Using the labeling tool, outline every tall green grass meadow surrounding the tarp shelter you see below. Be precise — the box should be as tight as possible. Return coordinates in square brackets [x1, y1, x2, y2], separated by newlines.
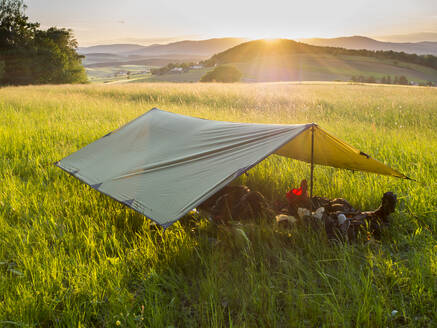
[0, 83, 437, 327]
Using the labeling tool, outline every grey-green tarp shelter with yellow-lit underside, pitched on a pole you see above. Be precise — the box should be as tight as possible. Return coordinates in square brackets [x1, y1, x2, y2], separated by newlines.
[56, 108, 406, 228]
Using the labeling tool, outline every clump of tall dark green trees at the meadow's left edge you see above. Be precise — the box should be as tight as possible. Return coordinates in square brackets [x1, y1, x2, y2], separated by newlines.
[0, 0, 87, 85]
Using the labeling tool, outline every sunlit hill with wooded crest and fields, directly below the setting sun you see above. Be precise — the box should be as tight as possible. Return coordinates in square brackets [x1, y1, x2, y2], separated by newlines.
[205, 39, 437, 82]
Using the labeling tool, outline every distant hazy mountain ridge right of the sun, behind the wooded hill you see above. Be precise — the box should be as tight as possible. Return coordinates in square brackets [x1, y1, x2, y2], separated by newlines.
[299, 36, 437, 55]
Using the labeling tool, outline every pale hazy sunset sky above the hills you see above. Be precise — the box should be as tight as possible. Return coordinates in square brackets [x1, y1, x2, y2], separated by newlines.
[25, 0, 437, 45]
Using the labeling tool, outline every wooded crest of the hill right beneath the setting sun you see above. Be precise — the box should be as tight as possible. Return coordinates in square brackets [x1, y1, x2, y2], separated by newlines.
[204, 39, 437, 69]
